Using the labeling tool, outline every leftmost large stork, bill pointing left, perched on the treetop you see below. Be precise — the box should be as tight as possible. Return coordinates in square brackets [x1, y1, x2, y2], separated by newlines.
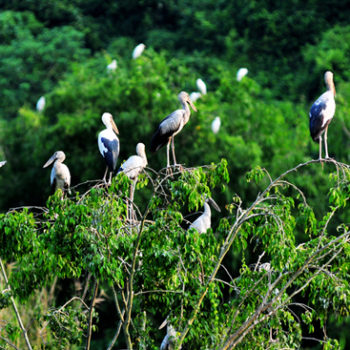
[43, 151, 71, 192]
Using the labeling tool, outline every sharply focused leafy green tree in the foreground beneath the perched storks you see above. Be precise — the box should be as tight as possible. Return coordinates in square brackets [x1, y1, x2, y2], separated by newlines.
[0, 160, 350, 349]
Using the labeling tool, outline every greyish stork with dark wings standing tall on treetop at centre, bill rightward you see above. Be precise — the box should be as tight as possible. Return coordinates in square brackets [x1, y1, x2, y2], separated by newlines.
[151, 91, 197, 168]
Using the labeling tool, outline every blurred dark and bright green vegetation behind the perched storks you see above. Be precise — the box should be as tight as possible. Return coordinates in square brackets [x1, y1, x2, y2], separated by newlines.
[0, 0, 350, 348]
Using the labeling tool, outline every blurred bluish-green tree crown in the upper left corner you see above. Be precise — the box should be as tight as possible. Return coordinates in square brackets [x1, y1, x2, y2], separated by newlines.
[0, 11, 88, 119]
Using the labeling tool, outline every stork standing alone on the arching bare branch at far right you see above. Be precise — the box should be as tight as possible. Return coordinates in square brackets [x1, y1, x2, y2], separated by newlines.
[309, 71, 335, 159]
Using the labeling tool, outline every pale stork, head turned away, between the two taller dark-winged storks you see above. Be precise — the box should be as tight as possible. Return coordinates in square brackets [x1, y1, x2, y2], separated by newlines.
[118, 142, 148, 219]
